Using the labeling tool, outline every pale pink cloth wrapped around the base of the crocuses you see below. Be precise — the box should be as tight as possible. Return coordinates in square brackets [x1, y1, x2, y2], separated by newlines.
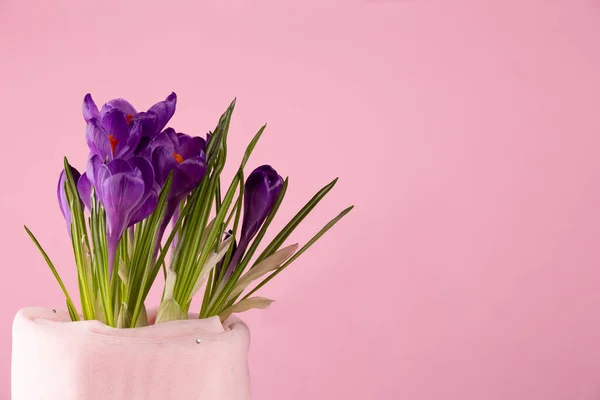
[12, 308, 250, 400]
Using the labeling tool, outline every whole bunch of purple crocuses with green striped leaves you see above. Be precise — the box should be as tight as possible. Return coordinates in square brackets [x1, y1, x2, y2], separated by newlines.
[25, 93, 352, 328]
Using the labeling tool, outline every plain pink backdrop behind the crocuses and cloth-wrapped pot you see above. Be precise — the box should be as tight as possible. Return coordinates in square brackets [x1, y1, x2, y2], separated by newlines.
[0, 0, 600, 400]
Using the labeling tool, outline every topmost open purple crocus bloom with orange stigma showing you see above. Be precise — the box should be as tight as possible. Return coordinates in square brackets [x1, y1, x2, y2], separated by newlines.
[82, 93, 177, 160]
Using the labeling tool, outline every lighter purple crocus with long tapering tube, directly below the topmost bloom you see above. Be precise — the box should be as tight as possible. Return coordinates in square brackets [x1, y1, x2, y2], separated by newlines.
[77, 155, 157, 271]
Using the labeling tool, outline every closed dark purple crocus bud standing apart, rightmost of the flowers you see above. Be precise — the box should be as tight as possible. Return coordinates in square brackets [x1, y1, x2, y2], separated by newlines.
[223, 165, 283, 282]
